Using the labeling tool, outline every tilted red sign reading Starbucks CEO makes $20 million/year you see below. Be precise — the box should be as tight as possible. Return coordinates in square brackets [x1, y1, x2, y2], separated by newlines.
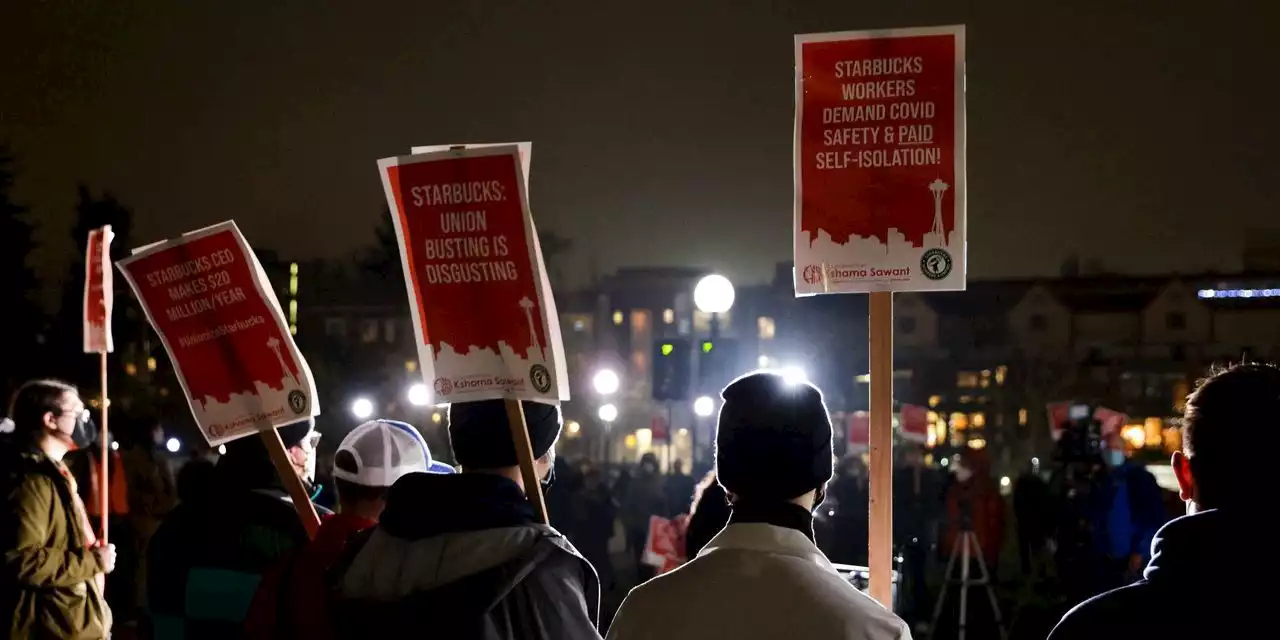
[116, 221, 319, 447]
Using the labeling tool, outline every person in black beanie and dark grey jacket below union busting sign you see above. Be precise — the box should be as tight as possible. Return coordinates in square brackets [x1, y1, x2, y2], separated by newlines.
[330, 399, 600, 640]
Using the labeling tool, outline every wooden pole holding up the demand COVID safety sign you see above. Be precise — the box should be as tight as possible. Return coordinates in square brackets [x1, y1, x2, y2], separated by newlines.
[867, 292, 893, 611]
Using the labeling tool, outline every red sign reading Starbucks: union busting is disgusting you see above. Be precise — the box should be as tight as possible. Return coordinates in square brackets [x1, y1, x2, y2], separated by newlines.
[378, 145, 568, 402]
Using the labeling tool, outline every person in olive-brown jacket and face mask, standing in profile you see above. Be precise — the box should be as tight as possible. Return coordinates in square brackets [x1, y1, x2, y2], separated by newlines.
[0, 380, 115, 639]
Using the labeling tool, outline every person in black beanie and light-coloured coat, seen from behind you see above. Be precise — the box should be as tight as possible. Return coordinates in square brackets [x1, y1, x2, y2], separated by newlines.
[608, 371, 911, 640]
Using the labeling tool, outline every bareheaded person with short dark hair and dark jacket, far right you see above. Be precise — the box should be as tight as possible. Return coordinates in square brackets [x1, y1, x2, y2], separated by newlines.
[1050, 364, 1280, 640]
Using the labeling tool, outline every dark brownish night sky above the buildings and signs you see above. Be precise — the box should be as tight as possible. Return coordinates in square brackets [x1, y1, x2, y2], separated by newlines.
[0, 0, 1280, 290]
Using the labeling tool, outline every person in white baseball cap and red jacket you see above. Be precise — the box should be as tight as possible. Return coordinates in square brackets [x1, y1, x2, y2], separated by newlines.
[246, 420, 454, 639]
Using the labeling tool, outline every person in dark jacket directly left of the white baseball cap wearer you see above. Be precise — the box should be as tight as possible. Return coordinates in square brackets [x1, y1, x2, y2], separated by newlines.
[147, 419, 328, 640]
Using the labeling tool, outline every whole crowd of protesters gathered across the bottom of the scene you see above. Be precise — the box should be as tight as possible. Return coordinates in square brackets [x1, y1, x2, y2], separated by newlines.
[0, 364, 1259, 640]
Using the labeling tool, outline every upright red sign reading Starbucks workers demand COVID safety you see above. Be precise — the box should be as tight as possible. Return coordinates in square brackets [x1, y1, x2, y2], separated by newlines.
[794, 27, 965, 296]
